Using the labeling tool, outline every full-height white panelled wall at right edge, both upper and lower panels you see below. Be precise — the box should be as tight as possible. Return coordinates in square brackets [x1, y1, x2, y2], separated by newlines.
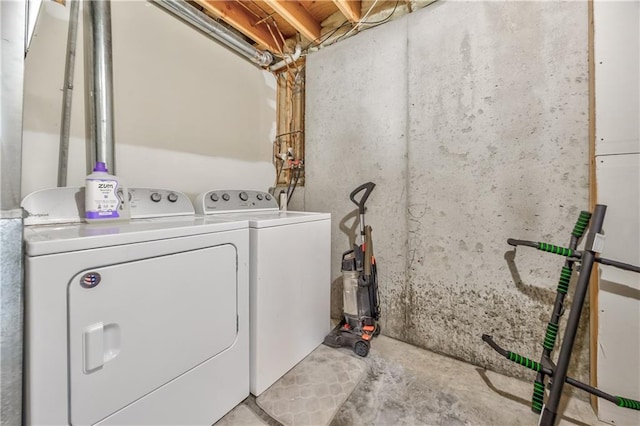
[593, 0, 640, 425]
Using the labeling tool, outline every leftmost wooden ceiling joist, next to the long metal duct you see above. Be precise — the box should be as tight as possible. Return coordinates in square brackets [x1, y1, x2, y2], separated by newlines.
[195, 0, 282, 52]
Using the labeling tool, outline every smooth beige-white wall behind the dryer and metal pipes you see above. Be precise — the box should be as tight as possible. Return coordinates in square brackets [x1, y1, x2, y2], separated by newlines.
[22, 1, 276, 196]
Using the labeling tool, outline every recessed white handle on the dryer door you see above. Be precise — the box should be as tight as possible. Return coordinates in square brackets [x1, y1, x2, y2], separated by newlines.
[82, 322, 120, 374]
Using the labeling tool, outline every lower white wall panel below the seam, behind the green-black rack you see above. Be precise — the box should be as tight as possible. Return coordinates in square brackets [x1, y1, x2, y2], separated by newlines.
[596, 154, 640, 425]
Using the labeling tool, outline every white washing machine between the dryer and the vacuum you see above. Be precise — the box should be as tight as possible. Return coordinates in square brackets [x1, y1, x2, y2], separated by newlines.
[195, 190, 331, 396]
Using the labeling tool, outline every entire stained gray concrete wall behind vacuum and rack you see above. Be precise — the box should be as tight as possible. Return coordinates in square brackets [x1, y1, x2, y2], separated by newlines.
[305, 2, 589, 380]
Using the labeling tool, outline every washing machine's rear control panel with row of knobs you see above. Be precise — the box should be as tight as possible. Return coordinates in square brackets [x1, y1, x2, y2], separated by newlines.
[195, 189, 278, 214]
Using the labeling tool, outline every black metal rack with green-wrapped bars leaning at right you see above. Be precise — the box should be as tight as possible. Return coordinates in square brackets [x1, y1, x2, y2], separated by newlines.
[482, 204, 640, 426]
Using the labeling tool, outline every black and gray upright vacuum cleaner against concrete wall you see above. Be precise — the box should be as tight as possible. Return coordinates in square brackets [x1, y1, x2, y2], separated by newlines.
[324, 182, 380, 357]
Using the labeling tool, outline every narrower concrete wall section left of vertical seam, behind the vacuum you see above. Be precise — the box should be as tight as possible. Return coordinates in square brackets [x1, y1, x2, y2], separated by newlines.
[304, 15, 407, 336]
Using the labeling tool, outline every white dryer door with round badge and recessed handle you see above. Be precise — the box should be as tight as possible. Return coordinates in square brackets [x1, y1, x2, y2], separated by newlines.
[68, 244, 238, 424]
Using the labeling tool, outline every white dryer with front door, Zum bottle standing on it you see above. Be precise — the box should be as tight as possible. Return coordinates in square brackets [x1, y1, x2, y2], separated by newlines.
[22, 188, 249, 425]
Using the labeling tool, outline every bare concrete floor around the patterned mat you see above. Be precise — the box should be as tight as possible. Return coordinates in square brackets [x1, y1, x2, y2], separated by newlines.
[221, 336, 606, 426]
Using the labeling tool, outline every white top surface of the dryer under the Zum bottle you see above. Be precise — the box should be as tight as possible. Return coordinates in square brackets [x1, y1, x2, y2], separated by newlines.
[24, 216, 248, 256]
